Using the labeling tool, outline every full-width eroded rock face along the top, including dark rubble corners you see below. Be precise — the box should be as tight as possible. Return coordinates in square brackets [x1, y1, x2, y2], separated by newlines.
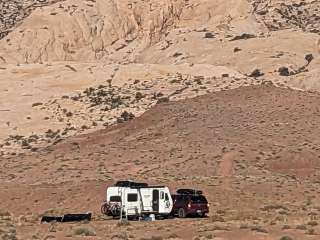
[0, 0, 320, 63]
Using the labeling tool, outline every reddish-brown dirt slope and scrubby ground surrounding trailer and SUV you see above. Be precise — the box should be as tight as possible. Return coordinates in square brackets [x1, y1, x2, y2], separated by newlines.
[0, 85, 320, 239]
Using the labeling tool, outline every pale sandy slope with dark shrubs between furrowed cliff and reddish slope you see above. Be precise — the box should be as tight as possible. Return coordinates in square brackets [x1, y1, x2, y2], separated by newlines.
[0, 63, 255, 155]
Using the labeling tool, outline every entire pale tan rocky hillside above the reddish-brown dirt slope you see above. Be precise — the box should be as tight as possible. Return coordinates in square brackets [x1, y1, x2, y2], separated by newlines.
[0, 0, 320, 158]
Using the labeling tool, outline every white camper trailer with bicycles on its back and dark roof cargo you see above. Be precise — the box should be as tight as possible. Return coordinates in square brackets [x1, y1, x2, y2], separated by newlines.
[102, 181, 173, 217]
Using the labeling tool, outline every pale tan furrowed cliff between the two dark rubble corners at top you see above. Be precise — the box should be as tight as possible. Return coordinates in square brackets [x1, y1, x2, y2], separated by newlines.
[0, 0, 260, 63]
